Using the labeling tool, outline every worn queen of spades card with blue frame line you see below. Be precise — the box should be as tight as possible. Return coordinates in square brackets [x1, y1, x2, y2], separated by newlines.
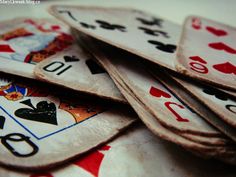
[0, 74, 136, 169]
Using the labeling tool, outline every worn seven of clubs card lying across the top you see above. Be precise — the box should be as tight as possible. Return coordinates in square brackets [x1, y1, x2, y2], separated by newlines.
[50, 5, 181, 70]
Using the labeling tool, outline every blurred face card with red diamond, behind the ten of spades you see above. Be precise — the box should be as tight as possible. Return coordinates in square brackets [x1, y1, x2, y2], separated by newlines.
[0, 18, 73, 78]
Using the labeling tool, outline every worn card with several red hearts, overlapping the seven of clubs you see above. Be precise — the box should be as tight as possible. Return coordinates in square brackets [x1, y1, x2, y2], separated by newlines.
[176, 16, 236, 91]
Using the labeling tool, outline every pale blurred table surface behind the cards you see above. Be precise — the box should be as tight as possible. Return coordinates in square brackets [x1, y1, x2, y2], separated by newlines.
[0, 0, 236, 27]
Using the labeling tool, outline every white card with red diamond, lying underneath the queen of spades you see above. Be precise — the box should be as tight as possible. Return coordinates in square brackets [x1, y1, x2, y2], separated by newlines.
[0, 126, 235, 177]
